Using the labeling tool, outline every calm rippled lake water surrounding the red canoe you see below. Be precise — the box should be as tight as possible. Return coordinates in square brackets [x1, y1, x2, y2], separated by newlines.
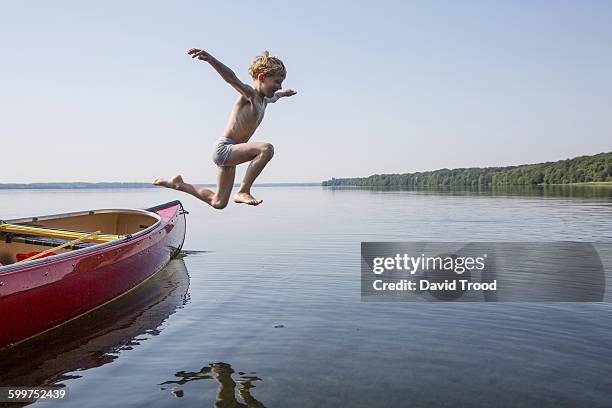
[0, 187, 612, 407]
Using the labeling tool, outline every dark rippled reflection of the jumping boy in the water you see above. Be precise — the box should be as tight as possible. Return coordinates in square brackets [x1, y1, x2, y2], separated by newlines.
[160, 363, 265, 408]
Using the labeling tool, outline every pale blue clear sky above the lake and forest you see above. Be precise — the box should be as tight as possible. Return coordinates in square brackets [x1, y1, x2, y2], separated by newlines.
[0, 0, 612, 183]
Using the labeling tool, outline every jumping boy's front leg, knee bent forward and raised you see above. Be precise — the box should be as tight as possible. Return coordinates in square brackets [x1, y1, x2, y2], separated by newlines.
[225, 142, 274, 205]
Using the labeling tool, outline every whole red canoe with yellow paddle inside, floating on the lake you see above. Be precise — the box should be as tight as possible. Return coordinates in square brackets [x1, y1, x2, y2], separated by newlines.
[0, 201, 186, 348]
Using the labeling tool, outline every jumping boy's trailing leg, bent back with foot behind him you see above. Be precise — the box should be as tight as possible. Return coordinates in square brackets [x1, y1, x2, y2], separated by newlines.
[153, 166, 236, 209]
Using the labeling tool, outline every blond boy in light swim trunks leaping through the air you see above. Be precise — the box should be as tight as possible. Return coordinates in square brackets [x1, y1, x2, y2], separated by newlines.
[153, 48, 296, 209]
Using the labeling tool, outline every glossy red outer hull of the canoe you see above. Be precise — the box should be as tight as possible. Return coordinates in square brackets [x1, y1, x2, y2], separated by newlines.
[0, 201, 185, 348]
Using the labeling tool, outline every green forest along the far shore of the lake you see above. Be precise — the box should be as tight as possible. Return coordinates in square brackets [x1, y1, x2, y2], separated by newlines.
[323, 152, 612, 187]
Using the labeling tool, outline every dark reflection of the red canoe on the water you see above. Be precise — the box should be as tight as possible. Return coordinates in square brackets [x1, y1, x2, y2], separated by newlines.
[0, 259, 189, 387]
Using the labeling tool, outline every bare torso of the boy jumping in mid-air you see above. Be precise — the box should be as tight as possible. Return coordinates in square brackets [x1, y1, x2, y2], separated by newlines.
[223, 95, 267, 143]
